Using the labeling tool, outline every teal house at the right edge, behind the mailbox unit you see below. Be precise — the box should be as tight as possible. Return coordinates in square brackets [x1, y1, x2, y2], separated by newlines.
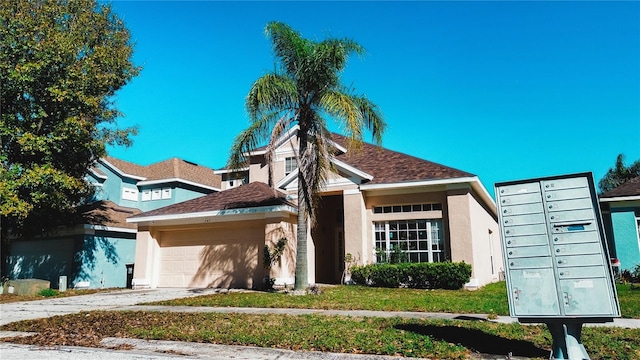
[600, 176, 640, 270]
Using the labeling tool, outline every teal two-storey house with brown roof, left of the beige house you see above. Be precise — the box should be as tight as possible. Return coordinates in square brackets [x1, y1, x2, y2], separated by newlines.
[4, 157, 220, 288]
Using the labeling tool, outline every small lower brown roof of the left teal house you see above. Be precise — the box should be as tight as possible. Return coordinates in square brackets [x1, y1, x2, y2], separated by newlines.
[78, 200, 142, 229]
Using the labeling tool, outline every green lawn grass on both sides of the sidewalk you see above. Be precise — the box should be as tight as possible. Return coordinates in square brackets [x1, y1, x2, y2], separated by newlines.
[0, 282, 640, 360]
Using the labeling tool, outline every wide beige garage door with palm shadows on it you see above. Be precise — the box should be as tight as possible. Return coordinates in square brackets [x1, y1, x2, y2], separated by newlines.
[158, 224, 264, 288]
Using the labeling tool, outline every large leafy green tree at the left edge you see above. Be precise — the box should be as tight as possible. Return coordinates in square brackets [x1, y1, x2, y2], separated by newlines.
[0, 0, 140, 239]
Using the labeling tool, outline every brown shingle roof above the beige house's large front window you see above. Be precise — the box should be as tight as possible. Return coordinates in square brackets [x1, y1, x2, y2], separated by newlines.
[332, 133, 475, 184]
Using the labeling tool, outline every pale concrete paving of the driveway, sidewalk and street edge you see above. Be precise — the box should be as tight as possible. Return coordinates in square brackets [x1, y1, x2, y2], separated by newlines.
[0, 289, 640, 360]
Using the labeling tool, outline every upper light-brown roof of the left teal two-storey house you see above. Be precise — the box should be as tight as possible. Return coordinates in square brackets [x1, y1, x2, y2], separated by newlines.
[99, 156, 221, 189]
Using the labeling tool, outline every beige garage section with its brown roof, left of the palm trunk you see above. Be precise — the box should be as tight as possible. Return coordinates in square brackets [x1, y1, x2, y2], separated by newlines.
[127, 182, 297, 289]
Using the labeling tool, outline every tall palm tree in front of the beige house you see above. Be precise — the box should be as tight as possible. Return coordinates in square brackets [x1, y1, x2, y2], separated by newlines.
[229, 22, 385, 290]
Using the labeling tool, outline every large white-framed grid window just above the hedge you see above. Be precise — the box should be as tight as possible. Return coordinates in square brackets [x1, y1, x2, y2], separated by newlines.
[374, 220, 444, 262]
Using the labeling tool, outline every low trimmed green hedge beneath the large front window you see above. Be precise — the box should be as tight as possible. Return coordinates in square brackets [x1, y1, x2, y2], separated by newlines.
[351, 262, 471, 290]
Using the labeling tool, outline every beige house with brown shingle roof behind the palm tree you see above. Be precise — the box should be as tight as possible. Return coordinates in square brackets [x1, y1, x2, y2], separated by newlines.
[127, 128, 503, 287]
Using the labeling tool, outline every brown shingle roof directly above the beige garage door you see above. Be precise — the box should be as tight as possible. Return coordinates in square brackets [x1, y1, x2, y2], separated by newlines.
[132, 182, 295, 218]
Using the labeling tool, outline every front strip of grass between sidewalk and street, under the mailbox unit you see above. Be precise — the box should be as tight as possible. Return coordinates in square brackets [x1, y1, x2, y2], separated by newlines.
[1, 311, 640, 360]
